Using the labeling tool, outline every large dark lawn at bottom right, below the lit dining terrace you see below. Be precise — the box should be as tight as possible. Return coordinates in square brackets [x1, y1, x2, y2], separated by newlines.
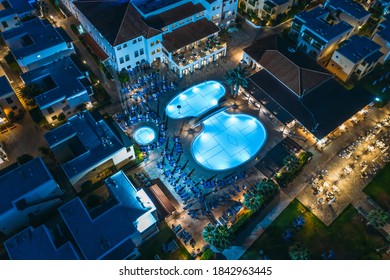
[242, 199, 385, 260]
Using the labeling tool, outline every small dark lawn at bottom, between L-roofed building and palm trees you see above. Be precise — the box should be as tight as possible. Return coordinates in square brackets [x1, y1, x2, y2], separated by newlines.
[140, 222, 193, 260]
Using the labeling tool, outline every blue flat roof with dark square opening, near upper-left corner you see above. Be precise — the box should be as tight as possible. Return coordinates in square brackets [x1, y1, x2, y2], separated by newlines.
[2, 18, 65, 59]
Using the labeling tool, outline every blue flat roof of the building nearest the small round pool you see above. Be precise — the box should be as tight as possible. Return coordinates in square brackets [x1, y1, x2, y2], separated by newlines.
[45, 111, 124, 178]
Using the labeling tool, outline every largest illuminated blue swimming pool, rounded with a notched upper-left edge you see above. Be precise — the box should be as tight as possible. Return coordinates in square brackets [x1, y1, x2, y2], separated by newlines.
[191, 112, 267, 171]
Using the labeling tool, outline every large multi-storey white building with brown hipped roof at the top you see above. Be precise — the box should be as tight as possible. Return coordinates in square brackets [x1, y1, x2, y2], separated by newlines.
[58, 0, 237, 77]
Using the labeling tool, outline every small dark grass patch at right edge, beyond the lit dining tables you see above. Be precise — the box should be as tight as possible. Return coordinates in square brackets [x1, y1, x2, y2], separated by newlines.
[364, 164, 390, 210]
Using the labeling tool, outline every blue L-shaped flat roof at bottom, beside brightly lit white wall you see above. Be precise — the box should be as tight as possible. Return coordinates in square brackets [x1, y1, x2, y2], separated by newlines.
[58, 197, 136, 260]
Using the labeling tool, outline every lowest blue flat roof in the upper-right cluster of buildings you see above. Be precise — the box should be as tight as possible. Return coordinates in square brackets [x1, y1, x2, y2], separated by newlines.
[337, 35, 383, 63]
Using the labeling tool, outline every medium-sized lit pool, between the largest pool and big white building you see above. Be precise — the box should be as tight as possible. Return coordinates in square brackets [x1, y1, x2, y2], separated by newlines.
[165, 81, 225, 119]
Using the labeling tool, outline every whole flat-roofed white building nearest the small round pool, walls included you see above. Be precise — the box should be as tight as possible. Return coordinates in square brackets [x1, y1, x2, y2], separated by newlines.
[45, 111, 135, 191]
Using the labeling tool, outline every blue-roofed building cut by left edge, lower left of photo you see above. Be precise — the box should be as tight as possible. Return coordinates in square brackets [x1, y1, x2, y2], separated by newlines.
[0, 158, 63, 236]
